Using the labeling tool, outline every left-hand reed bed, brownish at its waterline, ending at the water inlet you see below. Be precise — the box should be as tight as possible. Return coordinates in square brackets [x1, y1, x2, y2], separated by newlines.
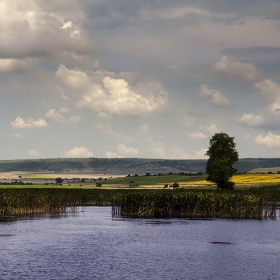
[0, 188, 132, 217]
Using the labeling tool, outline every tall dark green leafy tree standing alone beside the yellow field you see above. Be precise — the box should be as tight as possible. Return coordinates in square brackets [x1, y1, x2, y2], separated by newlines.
[205, 132, 239, 190]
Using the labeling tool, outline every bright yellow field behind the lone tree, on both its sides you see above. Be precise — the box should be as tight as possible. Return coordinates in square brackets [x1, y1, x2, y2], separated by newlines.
[179, 174, 280, 185]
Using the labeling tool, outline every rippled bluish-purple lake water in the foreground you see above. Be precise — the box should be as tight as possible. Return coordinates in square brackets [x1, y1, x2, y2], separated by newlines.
[0, 207, 280, 280]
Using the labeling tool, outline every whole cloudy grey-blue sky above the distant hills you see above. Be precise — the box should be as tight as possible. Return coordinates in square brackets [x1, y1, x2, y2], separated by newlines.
[0, 0, 280, 160]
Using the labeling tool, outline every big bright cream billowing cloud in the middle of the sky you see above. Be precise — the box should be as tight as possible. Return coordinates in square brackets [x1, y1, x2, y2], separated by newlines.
[56, 65, 168, 116]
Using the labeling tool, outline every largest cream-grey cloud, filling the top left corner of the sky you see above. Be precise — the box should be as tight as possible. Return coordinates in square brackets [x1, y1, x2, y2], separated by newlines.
[0, 0, 94, 59]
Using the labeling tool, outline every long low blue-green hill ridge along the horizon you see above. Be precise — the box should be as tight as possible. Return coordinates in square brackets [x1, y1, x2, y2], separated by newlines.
[0, 158, 280, 174]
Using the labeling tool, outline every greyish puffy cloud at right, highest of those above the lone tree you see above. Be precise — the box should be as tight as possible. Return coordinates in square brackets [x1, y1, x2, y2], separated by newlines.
[214, 56, 261, 82]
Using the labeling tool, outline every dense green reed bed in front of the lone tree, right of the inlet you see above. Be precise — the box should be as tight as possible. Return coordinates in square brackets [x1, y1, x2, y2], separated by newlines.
[112, 187, 280, 219]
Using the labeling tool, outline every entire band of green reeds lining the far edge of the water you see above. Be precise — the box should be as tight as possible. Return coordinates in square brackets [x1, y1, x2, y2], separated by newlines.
[0, 186, 280, 219]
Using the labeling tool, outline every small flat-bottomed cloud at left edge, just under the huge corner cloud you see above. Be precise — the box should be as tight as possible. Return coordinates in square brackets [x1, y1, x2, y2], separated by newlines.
[0, 58, 33, 73]
